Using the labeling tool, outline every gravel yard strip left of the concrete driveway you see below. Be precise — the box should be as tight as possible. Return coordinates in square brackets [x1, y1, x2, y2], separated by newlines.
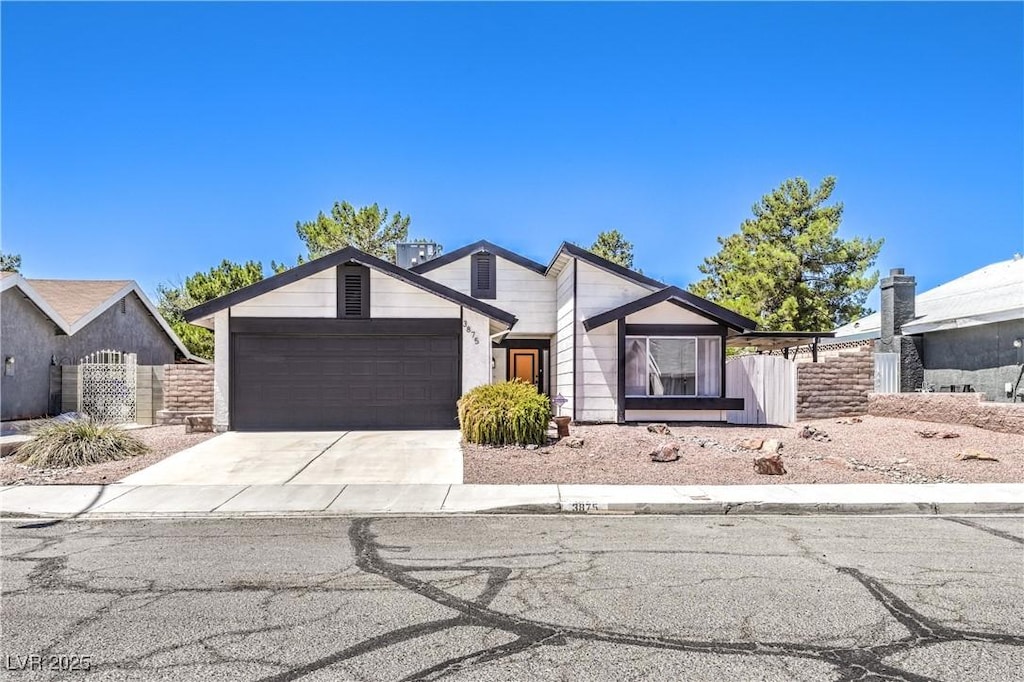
[0, 426, 216, 485]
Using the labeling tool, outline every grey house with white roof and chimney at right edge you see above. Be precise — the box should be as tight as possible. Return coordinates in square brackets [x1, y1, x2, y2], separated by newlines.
[835, 256, 1024, 401]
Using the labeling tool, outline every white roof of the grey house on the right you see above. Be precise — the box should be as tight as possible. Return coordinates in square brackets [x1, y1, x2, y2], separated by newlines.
[836, 258, 1024, 341]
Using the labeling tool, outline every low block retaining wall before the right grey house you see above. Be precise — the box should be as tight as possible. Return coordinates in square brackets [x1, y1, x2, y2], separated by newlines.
[867, 393, 1024, 433]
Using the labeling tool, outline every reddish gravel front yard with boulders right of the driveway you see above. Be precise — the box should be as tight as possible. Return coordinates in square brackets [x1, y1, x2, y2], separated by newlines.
[463, 417, 1024, 485]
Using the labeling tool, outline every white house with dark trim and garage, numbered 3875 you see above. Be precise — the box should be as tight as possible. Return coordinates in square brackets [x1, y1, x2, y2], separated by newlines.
[185, 242, 756, 430]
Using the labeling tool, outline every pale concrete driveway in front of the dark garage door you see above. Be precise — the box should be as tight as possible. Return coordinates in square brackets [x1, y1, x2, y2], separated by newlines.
[121, 431, 462, 485]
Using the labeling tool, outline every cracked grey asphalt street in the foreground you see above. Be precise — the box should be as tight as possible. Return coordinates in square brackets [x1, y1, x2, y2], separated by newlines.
[0, 515, 1024, 682]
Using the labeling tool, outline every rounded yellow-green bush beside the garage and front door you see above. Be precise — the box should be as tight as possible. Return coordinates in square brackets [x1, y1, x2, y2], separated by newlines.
[459, 379, 551, 445]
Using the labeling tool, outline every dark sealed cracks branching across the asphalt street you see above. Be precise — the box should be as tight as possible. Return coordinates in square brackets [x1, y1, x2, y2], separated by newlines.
[0, 518, 1024, 682]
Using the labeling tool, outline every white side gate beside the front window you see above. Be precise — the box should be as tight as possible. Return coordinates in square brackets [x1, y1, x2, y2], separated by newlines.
[725, 355, 797, 424]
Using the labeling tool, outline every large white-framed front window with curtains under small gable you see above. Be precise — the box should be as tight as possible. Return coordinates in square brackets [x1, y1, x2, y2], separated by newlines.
[626, 336, 722, 397]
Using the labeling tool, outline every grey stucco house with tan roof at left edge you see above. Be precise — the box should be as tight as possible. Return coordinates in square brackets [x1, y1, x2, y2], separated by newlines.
[0, 272, 194, 420]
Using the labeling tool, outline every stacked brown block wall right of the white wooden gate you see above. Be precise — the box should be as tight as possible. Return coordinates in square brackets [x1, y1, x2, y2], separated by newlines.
[797, 348, 874, 420]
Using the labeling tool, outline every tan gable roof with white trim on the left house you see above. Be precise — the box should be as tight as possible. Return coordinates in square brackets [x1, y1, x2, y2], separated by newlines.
[0, 272, 199, 363]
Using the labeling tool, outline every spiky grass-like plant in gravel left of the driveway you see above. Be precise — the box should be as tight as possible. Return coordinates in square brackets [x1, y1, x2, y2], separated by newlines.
[16, 419, 150, 469]
